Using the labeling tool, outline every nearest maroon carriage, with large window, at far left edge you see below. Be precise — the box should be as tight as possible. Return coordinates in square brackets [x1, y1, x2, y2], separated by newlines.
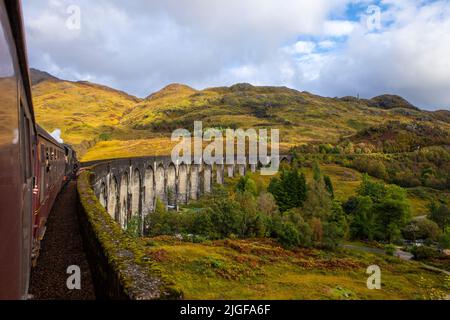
[0, 0, 36, 299]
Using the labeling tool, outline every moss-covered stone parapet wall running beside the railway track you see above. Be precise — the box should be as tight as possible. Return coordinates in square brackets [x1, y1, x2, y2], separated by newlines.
[77, 171, 183, 300]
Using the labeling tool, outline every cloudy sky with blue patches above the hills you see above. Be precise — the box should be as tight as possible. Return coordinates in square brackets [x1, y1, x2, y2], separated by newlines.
[23, 0, 450, 110]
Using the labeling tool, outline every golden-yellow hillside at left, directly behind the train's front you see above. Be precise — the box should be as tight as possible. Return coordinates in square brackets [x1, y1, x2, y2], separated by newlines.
[33, 73, 139, 145]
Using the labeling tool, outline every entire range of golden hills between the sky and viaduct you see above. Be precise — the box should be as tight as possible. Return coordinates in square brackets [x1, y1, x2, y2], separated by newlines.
[29, 72, 450, 160]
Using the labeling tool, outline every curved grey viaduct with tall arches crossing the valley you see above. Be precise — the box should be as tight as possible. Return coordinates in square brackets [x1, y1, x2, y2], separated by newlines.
[83, 155, 292, 228]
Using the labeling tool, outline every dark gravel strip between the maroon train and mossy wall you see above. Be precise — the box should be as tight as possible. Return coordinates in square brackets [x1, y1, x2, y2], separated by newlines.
[30, 182, 95, 300]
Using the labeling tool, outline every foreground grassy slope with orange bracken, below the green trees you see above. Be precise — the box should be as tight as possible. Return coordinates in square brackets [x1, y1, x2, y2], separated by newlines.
[144, 237, 450, 300]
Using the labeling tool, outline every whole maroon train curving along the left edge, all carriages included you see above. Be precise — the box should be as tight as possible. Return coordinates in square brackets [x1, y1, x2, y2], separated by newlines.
[0, 0, 77, 300]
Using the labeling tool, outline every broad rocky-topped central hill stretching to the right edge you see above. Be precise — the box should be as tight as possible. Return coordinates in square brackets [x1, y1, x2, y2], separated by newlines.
[121, 80, 448, 144]
